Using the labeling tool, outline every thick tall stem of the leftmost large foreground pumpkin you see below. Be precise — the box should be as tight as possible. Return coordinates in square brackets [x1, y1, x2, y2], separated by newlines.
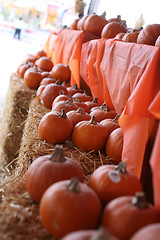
[49, 145, 66, 162]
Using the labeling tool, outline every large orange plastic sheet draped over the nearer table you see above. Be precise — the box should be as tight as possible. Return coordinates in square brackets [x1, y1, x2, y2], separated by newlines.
[80, 39, 160, 208]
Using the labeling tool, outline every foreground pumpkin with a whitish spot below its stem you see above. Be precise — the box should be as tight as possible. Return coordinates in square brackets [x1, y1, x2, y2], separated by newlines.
[88, 162, 143, 206]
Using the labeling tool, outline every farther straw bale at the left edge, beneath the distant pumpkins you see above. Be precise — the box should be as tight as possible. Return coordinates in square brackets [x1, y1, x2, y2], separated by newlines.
[0, 73, 36, 165]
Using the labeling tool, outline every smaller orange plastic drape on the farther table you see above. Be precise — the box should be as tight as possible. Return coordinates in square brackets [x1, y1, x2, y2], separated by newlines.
[51, 29, 99, 87]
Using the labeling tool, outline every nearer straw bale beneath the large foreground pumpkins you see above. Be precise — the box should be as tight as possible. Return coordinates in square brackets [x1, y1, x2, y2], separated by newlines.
[0, 98, 109, 240]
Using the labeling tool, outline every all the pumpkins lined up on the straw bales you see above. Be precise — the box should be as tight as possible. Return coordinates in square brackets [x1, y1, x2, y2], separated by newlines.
[17, 50, 160, 240]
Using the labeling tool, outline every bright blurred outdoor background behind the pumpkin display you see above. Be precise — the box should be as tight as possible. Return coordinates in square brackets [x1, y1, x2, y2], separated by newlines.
[0, 0, 160, 118]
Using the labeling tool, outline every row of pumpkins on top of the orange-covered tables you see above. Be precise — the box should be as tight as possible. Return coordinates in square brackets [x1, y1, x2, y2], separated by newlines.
[70, 14, 160, 47]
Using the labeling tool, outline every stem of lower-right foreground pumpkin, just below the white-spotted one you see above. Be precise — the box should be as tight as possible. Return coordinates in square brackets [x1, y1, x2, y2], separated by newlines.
[131, 192, 148, 209]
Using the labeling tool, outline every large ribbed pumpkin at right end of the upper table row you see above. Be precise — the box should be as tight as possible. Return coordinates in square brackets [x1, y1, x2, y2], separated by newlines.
[137, 24, 160, 46]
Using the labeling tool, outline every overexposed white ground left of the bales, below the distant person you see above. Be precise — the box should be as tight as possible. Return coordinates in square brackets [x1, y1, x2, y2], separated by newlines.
[0, 26, 49, 117]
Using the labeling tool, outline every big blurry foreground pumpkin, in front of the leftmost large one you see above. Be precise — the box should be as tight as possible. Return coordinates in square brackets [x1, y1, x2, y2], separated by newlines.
[40, 178, 101, 238]
